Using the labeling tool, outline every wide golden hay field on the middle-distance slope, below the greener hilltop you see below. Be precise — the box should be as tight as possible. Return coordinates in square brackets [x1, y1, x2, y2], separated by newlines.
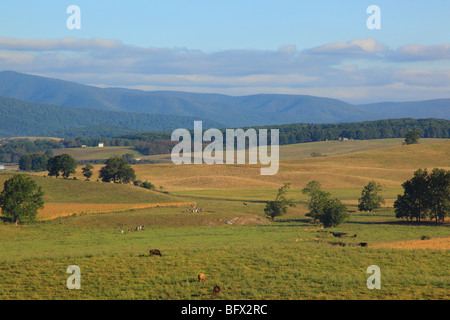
[130, 141, 450, 190]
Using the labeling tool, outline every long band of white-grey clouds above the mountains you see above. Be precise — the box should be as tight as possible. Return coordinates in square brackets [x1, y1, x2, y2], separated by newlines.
[0, 38, 450, 102]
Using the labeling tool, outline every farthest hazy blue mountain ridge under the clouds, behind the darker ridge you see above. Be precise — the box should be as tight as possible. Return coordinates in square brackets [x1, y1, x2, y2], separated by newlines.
[0, 71, 450, 127]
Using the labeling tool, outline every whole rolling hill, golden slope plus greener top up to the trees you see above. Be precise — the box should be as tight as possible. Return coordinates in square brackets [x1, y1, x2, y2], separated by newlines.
[129, 139, 450, 200]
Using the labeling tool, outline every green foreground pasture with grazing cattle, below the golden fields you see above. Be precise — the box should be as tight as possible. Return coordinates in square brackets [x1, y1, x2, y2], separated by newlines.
[0, 200, 450, 300]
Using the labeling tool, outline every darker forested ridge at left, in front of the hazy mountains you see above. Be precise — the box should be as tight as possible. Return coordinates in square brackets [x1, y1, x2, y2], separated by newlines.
[0, 97, 223, 137]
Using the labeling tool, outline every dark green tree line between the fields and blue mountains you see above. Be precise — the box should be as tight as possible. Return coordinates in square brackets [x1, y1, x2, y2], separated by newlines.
[0, 119, 450, 163]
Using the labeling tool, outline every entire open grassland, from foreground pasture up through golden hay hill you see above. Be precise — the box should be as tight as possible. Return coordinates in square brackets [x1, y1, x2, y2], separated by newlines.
[0, 141, 450, 300]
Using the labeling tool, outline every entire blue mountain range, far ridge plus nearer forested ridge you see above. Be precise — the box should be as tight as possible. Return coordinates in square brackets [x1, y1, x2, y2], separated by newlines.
[0, 71, 450, 136]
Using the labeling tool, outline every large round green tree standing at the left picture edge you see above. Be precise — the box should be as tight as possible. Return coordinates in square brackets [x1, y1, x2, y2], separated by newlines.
[0, 174, 44, 224]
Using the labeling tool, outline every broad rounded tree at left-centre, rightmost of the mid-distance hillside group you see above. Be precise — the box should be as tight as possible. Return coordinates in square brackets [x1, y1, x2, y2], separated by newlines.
[99, 156, 136, 183]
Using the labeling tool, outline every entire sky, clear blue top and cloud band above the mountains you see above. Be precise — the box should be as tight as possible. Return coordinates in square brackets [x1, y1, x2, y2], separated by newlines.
[0, 0, 450, 103]
